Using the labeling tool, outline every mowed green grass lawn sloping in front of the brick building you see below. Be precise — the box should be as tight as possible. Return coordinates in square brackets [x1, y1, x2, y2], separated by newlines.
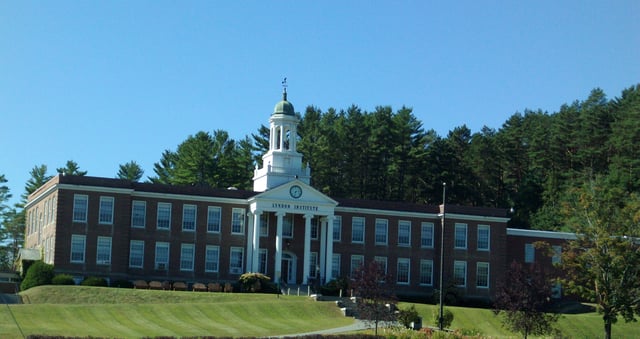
[0, 286, 640, 338]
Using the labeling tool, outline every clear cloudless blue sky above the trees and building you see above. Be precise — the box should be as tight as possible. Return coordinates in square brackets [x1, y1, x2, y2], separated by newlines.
[0, 0, 640, 206]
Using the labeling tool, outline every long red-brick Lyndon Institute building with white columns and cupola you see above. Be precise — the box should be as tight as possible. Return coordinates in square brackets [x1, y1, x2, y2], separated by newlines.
[25, 91, 568, 299]
